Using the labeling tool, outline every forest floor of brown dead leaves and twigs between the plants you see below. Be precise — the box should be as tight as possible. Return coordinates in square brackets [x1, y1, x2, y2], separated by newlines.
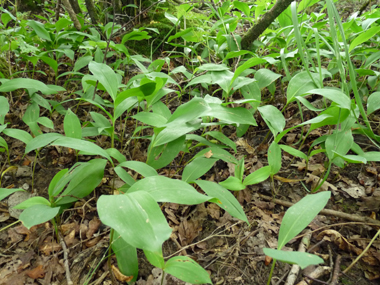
[0, 0, 380, 285]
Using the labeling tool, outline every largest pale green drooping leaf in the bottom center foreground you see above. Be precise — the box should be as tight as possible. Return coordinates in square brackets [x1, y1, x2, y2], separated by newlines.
[97, 191, 172, 252]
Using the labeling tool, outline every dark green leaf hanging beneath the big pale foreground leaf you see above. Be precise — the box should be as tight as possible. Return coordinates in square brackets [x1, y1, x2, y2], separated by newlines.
[111, 230, 139, 282]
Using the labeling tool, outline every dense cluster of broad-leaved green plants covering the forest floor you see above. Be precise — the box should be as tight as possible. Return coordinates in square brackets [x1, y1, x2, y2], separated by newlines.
[0, 0, 380, 284]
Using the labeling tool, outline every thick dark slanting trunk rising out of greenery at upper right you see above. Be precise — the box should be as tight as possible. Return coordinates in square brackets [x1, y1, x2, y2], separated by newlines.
[241, 0, 293, 49]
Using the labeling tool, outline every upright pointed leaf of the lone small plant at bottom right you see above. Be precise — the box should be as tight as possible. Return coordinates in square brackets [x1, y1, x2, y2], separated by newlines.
[278, 191, 331, 250]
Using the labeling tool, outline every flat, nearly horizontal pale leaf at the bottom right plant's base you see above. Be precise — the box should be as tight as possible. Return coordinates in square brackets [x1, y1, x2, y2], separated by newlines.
[263, 248, 324, 269]
